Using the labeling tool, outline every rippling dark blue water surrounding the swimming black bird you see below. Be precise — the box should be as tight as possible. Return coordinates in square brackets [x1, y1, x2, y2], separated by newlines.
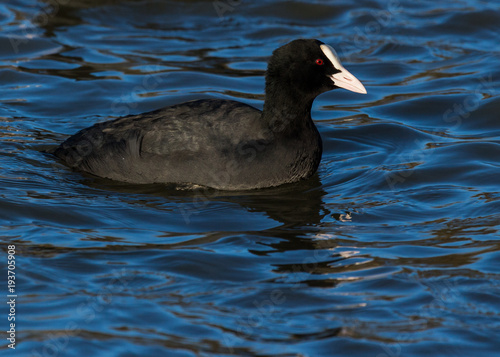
[0, 0, 500, 357]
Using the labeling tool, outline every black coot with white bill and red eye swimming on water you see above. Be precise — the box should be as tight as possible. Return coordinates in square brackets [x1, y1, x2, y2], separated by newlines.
[53, 39, 366, 190]
